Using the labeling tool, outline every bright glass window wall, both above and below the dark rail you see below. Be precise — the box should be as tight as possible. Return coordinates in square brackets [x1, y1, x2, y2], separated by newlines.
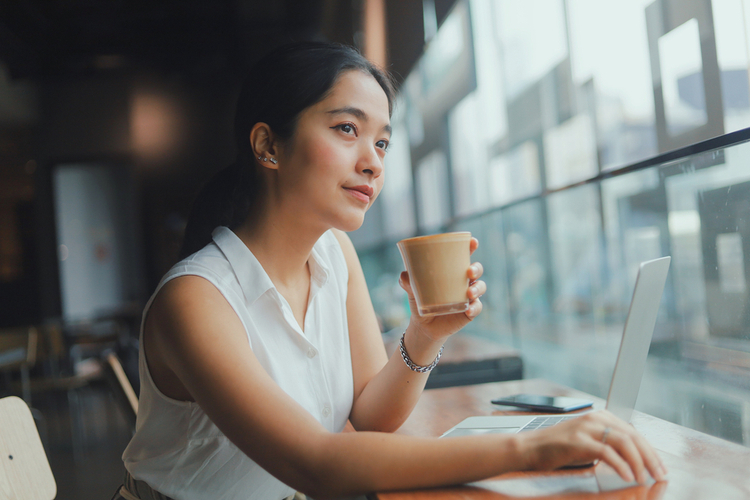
[360, 0, 750, 446]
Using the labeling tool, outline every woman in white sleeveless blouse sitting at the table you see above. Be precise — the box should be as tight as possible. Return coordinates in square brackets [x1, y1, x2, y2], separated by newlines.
[116, 43, 663, 500]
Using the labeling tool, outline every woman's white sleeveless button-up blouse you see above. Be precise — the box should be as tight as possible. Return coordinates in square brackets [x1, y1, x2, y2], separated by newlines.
[123, 227, 354, 500]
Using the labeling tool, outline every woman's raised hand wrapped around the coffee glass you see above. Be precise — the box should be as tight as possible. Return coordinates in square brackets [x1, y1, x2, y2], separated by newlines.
[399, 238, 487, 341]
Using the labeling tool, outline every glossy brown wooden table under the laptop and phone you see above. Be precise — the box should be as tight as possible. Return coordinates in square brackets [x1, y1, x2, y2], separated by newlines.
[368, 379, 750, 500]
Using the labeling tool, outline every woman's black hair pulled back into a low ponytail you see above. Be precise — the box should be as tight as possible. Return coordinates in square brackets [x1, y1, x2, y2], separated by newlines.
[180, 42, 395, 259]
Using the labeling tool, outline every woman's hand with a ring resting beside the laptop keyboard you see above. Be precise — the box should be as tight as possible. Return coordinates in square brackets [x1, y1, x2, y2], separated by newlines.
[517, 410, 667, 484]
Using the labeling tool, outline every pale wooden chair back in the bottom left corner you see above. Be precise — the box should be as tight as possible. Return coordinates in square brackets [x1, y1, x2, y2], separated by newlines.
[0, 396, 57, 500]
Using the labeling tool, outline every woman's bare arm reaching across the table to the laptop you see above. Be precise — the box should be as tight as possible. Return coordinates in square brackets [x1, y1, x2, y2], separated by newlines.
[144, 276, 658, 498]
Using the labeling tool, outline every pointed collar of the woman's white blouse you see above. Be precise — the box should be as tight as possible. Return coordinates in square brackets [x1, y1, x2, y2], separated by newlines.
[212, 226, 330, 305]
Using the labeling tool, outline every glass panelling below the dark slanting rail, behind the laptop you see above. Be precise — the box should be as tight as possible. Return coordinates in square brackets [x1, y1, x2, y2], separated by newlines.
[360, 129, 750, 446]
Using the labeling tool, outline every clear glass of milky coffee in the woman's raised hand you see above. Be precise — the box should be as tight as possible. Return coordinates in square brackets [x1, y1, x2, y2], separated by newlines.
[398, 231, 471, 316]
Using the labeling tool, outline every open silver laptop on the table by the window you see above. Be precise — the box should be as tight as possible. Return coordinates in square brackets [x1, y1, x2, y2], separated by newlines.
[441, 257, 671, 437]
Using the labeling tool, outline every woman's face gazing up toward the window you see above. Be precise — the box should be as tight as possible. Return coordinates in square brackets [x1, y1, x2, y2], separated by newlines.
[277, 70, 391, 231]
